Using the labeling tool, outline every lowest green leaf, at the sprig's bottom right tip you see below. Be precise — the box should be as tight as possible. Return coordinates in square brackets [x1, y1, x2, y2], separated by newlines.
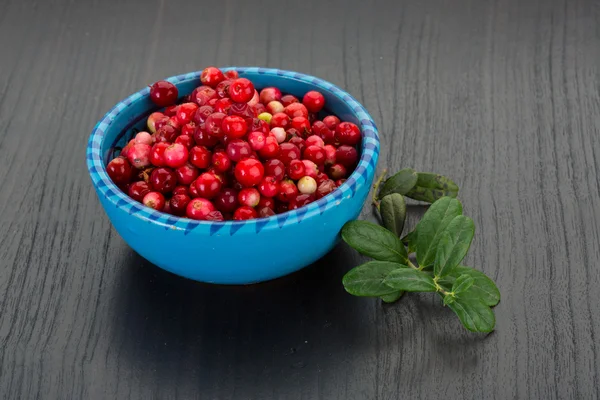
[447, 291, 496, 332]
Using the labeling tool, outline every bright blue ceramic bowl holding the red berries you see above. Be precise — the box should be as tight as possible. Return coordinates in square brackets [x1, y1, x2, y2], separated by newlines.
[87, 67, 379, 284]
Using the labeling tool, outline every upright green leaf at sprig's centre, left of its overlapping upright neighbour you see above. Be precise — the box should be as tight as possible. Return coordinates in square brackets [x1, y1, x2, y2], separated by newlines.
[416, 197, 462, 267]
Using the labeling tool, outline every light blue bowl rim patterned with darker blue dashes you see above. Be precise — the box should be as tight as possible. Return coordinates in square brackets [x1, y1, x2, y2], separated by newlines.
[86, 66, 380, 236]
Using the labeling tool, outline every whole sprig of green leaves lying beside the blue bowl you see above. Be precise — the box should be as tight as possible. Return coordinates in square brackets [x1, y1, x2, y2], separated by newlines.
[342, 168, 500, 332]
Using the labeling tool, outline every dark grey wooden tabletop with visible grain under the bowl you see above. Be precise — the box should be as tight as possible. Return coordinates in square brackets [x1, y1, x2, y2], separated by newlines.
[0, 0, 600, 400]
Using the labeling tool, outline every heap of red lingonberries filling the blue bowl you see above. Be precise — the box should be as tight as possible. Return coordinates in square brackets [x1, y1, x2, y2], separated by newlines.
[106, 67, 361, 221]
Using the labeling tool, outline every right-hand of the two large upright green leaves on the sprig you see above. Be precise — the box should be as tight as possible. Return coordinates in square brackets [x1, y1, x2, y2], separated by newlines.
[433, 215, 475, 277]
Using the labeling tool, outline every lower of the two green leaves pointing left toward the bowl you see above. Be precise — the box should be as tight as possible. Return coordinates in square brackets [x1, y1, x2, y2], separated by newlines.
[342, 261, 408, 297]
